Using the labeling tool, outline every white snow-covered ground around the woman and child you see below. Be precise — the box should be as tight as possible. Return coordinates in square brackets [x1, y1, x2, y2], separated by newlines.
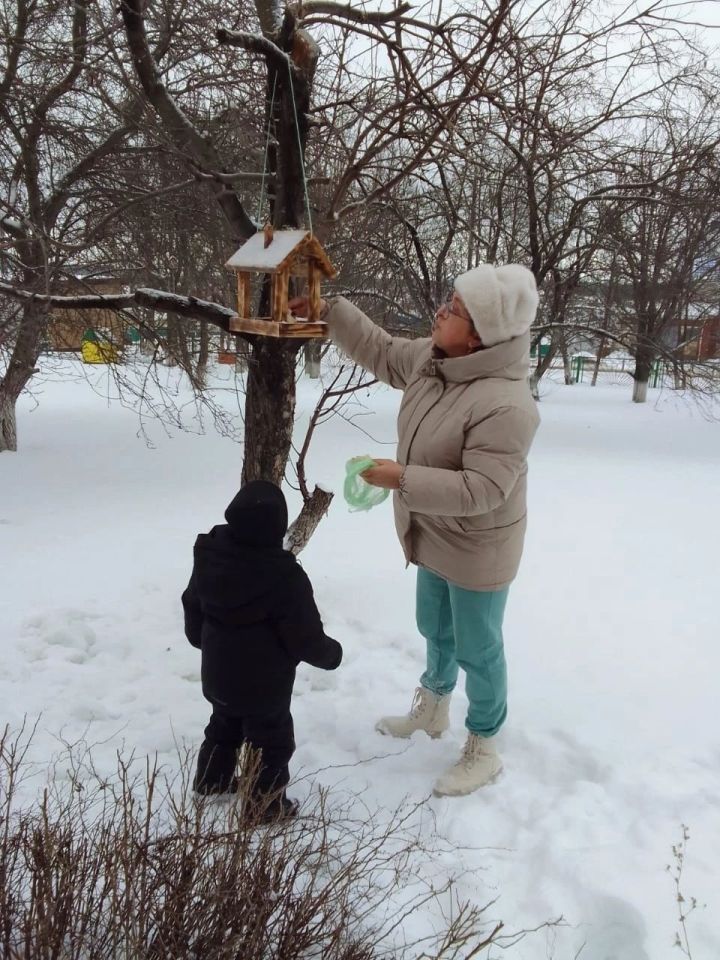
[0, 361, 720, 960]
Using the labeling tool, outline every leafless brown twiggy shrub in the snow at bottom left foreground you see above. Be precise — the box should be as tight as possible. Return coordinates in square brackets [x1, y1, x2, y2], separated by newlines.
[0, 728, 502, 960]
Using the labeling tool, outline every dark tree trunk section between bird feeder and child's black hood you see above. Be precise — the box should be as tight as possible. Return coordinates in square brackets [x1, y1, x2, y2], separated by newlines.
[242, 337, 299, 486]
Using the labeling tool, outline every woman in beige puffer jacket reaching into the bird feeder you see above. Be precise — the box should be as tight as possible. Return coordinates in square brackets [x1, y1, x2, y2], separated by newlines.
[290, 264, 539, 796]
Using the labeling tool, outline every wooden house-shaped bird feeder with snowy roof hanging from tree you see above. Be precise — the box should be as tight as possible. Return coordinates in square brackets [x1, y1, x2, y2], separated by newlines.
[225, 226, 337, 339]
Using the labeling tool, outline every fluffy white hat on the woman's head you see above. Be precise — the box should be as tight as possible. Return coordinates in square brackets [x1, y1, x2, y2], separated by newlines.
[455, 263, 538, 347]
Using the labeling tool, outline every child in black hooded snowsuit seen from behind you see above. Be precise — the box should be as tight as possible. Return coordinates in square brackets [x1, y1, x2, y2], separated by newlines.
[182, 480, 342, 819]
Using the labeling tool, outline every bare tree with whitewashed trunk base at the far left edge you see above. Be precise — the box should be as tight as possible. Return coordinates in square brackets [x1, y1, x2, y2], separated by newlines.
[0, 0, 180, 451]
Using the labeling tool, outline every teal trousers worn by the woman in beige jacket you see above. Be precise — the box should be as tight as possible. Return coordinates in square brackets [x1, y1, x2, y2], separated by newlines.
[416, 567, 509, 737]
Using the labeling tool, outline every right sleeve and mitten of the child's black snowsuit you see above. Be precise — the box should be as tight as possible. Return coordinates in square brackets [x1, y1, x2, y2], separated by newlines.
[277, 567, 342, 670]
